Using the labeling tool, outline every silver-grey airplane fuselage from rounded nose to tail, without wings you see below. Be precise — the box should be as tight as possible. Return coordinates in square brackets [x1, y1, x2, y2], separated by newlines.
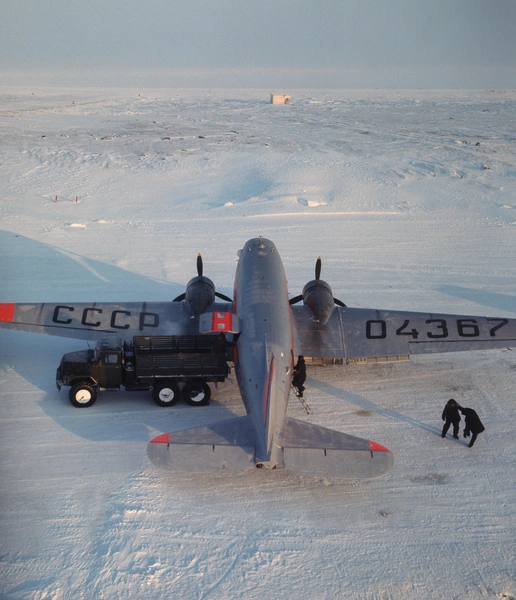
[234, 238, 293, 468]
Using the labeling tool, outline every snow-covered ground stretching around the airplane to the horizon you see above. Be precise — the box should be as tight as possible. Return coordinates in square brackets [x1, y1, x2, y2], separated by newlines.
[0, 88, 516, 600]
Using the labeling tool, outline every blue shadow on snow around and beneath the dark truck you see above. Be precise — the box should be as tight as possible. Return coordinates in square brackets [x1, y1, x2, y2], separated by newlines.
[0, 330, 236, 442]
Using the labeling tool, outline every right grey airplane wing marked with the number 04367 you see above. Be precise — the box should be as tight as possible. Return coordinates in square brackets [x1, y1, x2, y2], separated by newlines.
[292, 306, 516, 364]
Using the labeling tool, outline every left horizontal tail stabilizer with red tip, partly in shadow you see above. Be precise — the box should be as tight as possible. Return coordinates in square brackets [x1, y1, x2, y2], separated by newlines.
[147, 417, 256, 473]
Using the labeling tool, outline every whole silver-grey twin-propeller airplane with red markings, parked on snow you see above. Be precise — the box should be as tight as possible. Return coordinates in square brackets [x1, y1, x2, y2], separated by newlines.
[0, 237, 516, 479]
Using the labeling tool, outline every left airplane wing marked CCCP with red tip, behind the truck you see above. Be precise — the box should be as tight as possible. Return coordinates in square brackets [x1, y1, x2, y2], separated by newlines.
[0, 302, 231, 340]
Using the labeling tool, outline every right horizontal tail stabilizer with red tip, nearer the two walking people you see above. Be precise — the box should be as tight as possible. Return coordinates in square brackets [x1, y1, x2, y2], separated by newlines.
[282, 419, 394, 479]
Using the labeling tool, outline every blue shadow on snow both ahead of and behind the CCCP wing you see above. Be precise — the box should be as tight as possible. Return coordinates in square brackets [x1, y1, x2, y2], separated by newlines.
[0, 231, 236, 441]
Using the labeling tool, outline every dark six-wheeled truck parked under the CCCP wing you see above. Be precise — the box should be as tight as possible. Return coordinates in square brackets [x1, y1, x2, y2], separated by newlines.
[56, 335, 230, 408]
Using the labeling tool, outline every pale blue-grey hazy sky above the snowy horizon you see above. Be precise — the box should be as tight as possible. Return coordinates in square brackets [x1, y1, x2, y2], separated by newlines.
[0, 0, 516, 89]
